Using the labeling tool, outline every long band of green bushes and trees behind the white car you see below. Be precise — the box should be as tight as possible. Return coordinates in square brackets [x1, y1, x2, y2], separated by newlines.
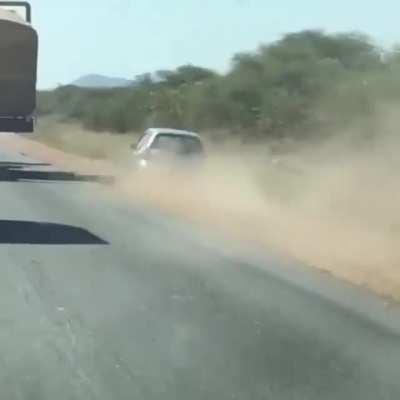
[38, 31, 400, 140]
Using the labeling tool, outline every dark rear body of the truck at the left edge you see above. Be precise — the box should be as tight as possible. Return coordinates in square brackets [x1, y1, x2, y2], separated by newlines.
[0, 2, 38, 132]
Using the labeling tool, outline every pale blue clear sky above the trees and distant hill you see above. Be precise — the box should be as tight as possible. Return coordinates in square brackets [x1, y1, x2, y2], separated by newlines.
[16, 0, 400, 89]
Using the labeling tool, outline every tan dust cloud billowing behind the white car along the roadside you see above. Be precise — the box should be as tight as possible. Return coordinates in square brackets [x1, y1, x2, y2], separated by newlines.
[118, 109, 400, 300]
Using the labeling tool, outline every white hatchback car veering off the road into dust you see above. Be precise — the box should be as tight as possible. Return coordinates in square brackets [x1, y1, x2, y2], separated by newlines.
[131, 128, 205, 168]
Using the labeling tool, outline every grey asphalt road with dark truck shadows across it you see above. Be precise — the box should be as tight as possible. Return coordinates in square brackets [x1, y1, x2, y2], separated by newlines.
[0, 148, 400, 400]
